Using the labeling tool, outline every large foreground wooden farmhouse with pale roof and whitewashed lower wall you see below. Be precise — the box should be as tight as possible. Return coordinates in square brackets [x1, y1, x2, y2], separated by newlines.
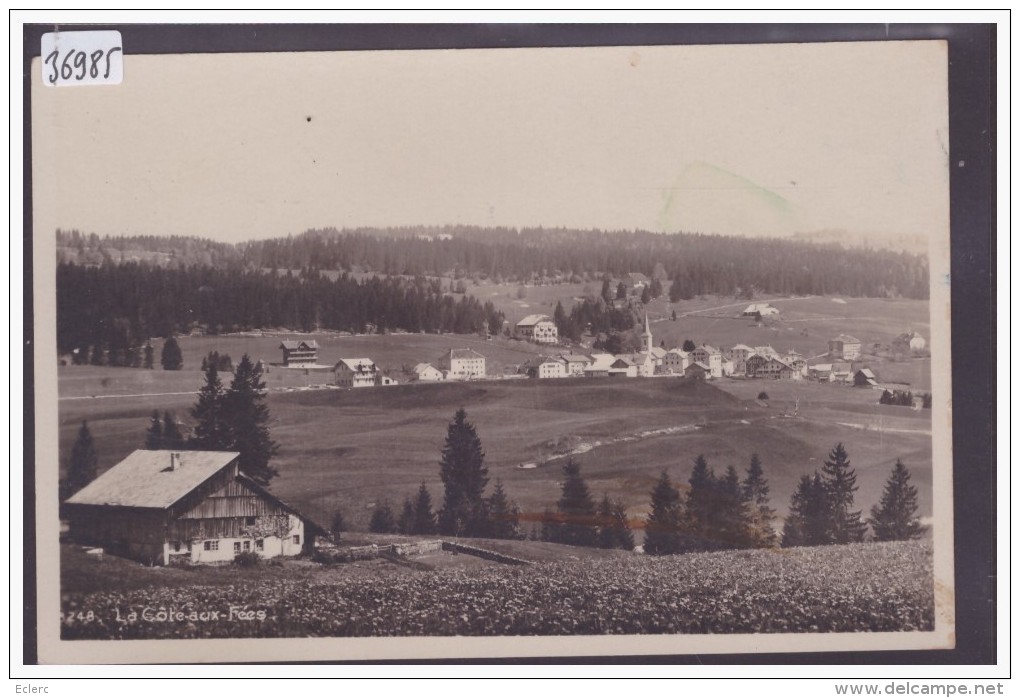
[66, 450, 326, 565]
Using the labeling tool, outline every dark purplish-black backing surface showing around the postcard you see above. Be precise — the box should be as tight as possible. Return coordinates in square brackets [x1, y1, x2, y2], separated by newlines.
[21, 20, 997, 665]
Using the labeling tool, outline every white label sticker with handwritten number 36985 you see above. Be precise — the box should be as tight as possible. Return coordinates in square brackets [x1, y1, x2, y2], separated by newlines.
[41, 32, 124, 87]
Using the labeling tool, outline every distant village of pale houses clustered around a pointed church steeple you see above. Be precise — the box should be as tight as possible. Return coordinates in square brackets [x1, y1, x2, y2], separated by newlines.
[279, 303, 926, 390]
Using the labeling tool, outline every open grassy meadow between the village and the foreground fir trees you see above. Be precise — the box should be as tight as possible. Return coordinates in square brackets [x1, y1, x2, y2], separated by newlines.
[60, 367, 931, 530]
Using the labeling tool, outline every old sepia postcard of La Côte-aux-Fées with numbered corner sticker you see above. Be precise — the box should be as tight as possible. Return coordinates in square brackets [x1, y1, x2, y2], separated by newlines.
[31, 31, 955, 663]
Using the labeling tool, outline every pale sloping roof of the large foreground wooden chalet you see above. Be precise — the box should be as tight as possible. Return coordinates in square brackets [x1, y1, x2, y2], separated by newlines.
[67, 450, 239, 509]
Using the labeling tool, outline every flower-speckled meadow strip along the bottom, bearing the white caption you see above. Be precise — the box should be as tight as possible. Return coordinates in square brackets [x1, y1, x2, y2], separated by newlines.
[61, 541, 934, 639]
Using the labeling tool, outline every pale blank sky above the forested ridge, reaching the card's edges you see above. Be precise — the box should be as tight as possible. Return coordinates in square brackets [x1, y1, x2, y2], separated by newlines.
[33, 42, 949, 242]
